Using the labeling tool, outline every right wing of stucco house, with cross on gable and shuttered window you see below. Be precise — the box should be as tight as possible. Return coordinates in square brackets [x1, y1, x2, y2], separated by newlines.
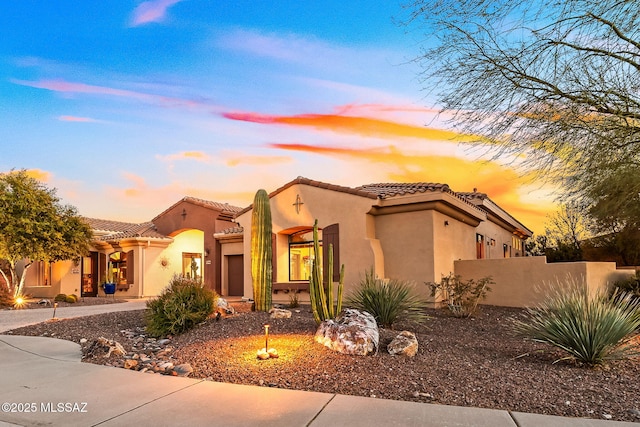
[215, 177, 532, 299]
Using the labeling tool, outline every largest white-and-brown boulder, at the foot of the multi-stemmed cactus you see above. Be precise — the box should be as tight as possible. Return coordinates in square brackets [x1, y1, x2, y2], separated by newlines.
[315, 308, 380, 356]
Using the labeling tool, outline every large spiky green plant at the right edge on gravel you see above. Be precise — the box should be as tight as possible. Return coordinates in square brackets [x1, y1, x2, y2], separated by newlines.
[514, 283, 640, 366]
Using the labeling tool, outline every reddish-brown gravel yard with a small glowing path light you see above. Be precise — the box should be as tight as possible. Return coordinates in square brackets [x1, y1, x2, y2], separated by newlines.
[2, 304, 640, 422]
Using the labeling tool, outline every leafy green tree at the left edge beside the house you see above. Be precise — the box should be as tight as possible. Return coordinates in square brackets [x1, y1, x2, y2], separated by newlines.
[0, 170, 92, 297]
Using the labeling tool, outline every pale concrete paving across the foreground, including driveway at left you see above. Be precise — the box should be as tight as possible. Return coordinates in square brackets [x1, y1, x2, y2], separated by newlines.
[0, 303, 639, 427]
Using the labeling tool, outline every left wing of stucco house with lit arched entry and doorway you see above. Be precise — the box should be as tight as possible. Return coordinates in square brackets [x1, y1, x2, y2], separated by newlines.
[25, 197, 241, 298]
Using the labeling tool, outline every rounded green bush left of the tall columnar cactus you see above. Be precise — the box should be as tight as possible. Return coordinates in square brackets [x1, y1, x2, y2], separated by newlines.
[146, 275, 218, 337]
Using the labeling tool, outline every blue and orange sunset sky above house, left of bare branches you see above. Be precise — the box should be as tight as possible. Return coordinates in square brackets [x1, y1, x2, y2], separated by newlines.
[0, 0, 554, 233]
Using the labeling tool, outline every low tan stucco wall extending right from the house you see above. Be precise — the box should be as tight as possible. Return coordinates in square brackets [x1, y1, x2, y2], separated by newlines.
[454, 256, 634, 307]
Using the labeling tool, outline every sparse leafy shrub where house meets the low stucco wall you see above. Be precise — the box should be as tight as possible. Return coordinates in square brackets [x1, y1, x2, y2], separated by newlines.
[426, 273, 495, 317]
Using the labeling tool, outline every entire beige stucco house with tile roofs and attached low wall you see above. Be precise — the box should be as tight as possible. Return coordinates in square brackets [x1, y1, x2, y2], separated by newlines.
[20, 177, 633, 307]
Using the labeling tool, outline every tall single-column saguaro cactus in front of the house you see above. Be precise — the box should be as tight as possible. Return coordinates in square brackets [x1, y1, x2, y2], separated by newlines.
[251, 189, 273, 311]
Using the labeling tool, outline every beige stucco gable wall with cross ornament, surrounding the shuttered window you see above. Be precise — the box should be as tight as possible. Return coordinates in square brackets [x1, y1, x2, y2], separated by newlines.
[237, 184, 384, 301]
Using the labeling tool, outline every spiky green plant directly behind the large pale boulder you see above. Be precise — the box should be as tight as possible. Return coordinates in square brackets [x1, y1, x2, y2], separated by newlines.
[345, 268, 427, 328]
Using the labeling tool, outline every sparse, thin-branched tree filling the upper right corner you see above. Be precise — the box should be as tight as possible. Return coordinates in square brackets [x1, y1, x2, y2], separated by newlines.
[407, 0, 640, 217]
